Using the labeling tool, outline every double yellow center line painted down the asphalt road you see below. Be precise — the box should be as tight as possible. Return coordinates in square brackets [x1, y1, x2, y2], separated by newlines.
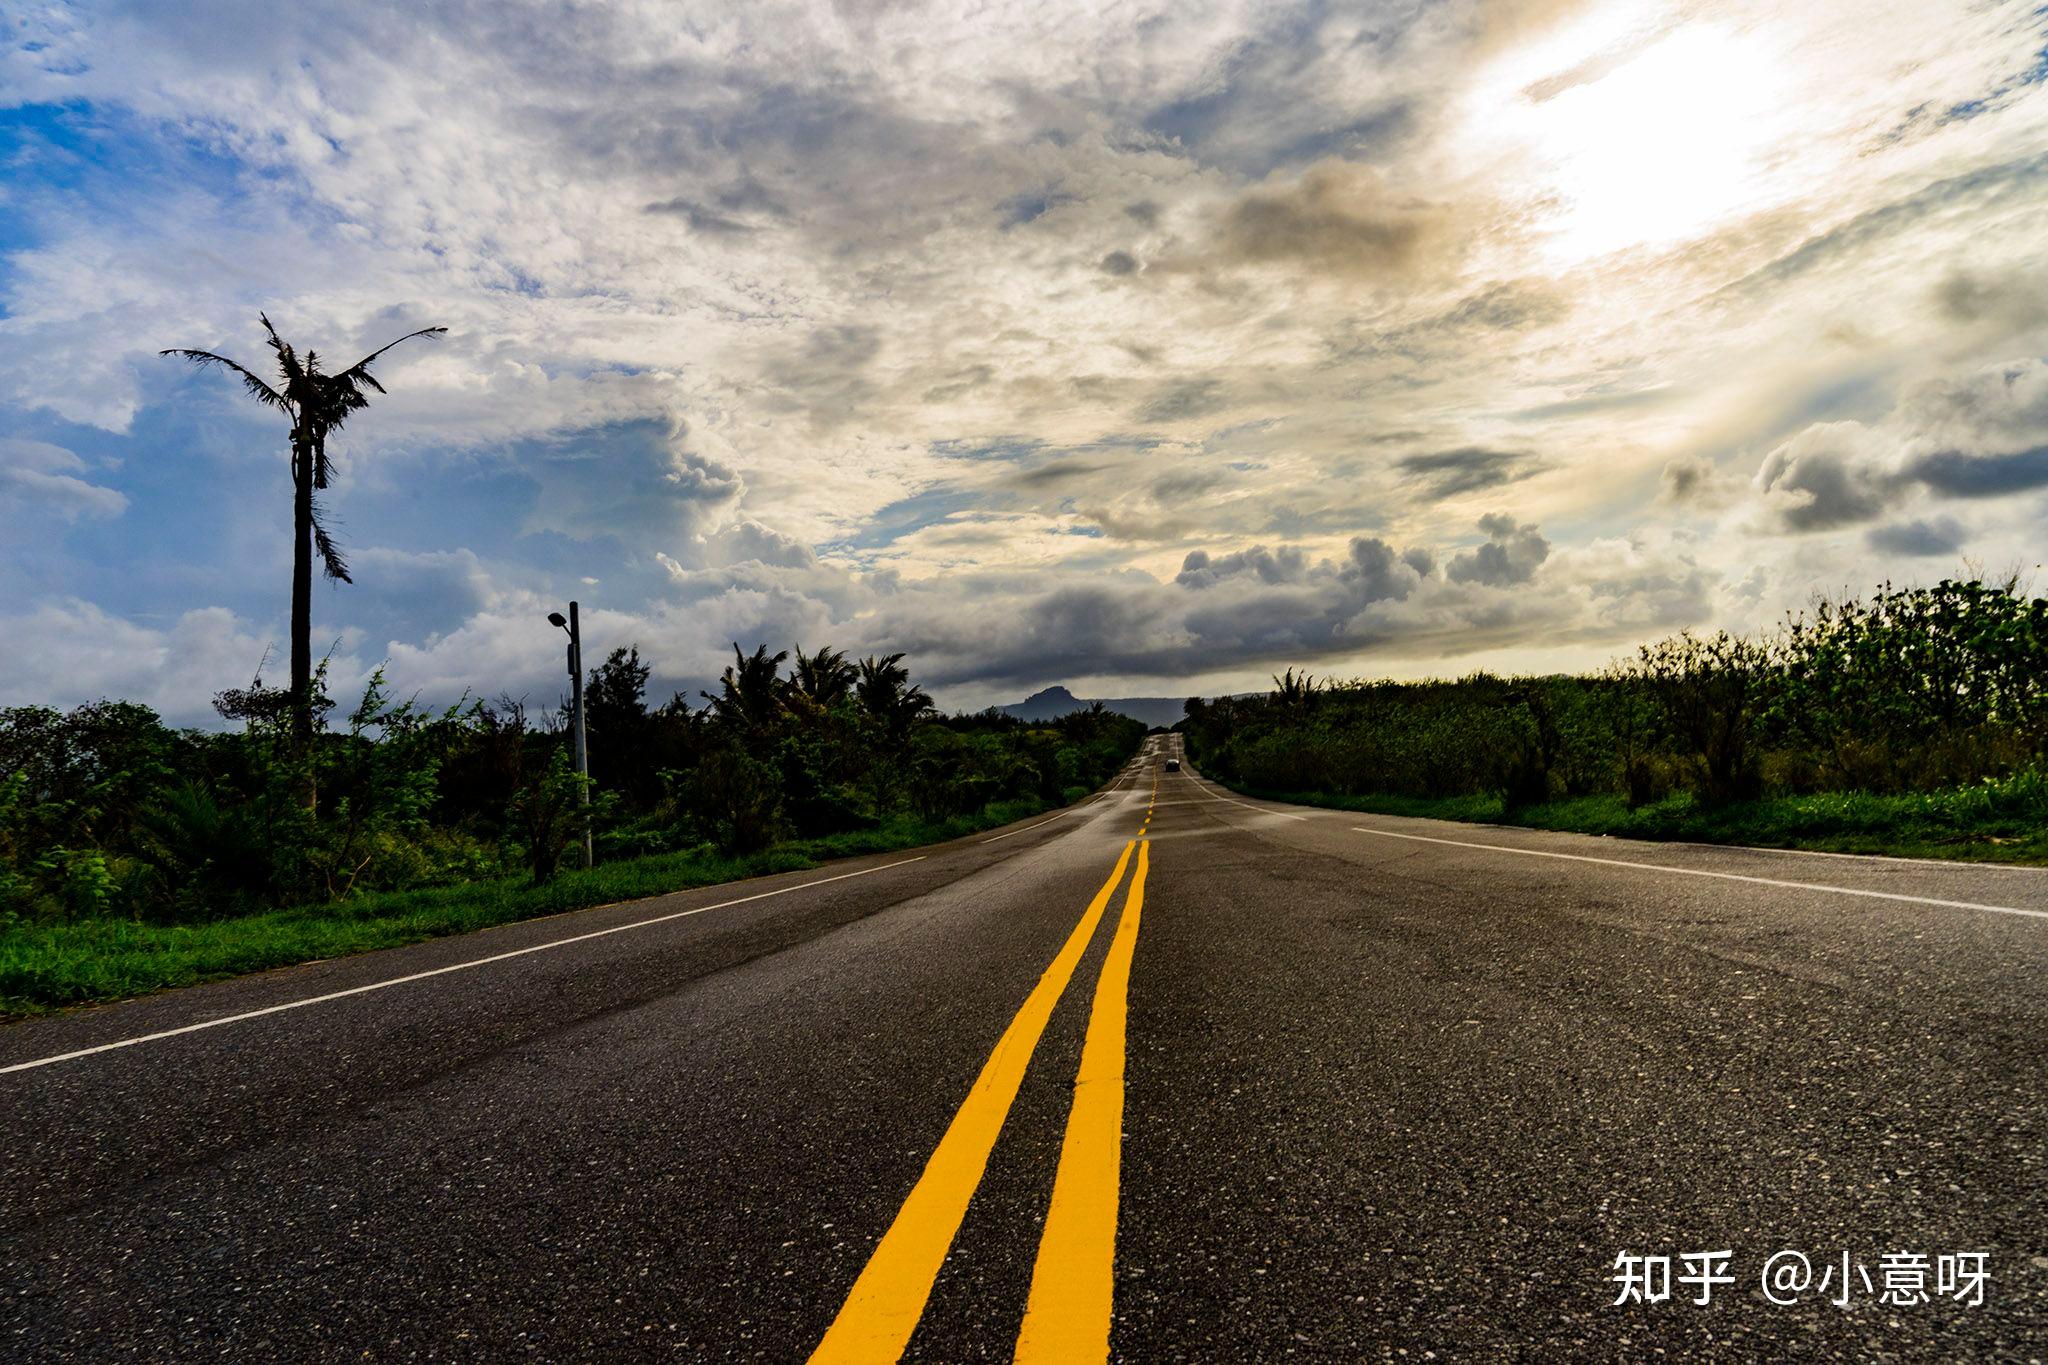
[811, 806, 1151, 1365]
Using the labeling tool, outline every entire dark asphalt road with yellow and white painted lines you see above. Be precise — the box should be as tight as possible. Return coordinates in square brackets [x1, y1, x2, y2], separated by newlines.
[0, 741, 2048, 1361]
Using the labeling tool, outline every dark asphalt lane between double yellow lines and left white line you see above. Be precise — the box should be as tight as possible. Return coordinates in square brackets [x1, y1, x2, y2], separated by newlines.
[0, 769, 1137, 1359]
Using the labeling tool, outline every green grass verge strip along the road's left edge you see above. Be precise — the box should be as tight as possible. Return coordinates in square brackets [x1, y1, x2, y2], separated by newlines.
[0, 800, 1047, 1017]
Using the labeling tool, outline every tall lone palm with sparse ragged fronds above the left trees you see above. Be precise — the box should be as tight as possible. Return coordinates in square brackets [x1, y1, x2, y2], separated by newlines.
[160, 313, 446, 745]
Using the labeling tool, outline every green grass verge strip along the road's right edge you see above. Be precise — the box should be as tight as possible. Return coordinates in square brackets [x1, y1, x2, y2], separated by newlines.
[1229, 774, 2048, 864]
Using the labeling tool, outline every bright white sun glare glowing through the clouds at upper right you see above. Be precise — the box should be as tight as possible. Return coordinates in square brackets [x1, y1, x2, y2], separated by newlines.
[1518, 25, 1788, 264]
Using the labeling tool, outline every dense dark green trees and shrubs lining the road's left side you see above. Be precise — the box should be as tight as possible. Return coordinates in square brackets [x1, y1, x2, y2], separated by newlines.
[0, 645, 1143, 923]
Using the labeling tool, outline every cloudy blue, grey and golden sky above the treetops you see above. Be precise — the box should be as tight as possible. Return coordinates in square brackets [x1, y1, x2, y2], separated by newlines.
[0, 0, 2048, 722]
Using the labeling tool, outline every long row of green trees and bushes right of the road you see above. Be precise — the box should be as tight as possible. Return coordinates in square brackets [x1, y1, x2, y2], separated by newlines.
[1182, 579, 2048, 817]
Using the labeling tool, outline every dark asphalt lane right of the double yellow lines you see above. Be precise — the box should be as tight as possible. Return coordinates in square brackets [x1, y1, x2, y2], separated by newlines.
[1118, 740, 2048, 1359]
